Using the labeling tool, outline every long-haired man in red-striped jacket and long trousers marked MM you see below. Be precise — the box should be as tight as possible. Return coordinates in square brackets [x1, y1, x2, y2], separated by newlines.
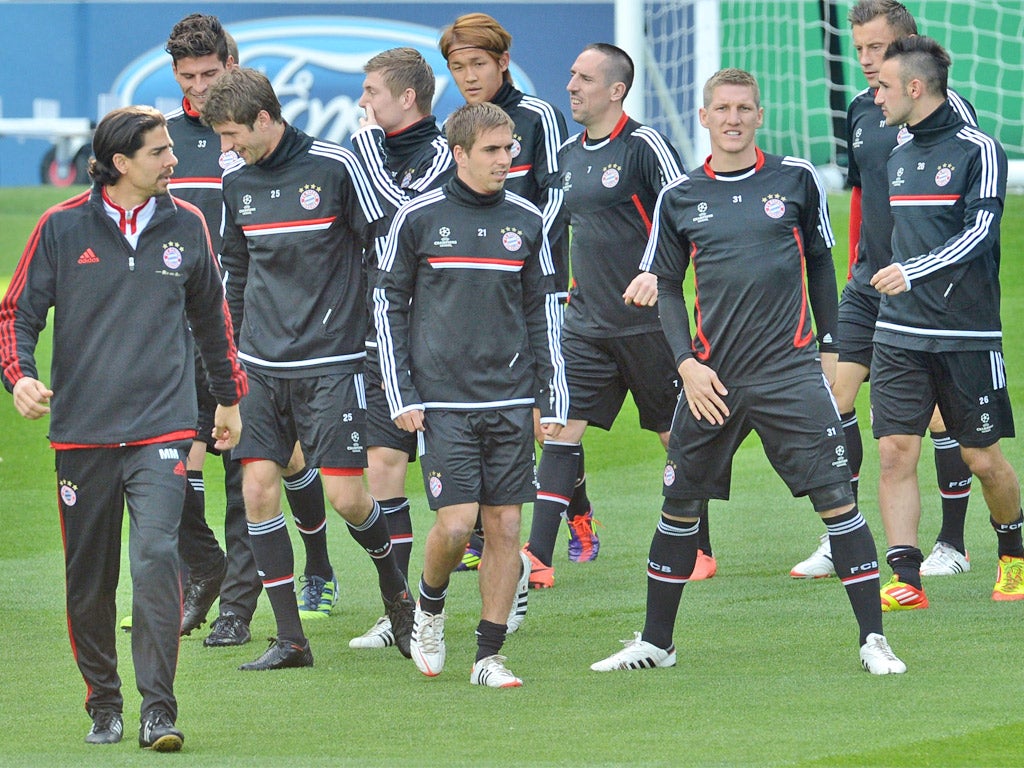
[0, 106, 247, 752]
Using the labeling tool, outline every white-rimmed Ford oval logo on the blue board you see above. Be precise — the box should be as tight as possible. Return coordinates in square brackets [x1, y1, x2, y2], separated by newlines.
[112, 16, 534, 143]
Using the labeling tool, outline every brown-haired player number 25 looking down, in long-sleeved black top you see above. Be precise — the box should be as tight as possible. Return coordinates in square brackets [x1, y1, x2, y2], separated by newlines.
[203, 68, 414, 670]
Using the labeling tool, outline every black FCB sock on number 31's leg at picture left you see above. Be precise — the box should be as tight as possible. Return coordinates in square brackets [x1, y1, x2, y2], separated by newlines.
[641, 515, 700, 649]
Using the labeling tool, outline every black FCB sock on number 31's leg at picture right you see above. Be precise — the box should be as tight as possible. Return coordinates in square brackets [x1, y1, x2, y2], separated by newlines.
[825, 507, 883, 645]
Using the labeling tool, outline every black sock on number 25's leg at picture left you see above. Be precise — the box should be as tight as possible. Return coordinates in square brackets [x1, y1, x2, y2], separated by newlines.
[249, 514, 306, 645]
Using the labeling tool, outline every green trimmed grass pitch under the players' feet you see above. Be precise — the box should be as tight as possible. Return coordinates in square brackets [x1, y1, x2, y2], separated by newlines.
[0, 188, 1024, 767]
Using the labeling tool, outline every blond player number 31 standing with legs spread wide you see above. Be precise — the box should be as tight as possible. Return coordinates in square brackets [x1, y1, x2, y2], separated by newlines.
[591, 69, 906, 675]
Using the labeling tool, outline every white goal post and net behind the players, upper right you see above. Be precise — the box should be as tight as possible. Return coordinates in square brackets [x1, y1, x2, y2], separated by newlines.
[634, 0, 1024, 187]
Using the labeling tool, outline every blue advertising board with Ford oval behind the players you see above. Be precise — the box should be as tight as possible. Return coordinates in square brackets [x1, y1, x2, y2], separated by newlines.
[0, 0, 613, 185]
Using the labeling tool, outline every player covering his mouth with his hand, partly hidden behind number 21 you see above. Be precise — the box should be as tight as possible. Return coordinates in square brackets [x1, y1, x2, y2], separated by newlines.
[348, 48, 455, 648]
